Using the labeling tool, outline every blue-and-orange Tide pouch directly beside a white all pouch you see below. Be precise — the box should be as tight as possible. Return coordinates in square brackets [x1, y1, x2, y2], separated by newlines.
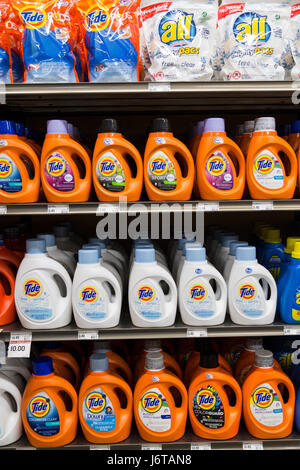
[77, 0, 140, 83]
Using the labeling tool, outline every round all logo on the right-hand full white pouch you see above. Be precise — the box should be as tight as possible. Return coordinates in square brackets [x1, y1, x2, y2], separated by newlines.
[233, 12, 271, 47]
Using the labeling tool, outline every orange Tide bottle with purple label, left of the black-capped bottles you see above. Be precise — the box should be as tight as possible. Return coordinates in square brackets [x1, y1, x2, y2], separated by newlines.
[41, 120, 92, 202]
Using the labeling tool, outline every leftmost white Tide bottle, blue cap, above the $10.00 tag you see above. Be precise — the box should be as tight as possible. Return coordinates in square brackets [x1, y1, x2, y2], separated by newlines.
[15, 239, 72, 330]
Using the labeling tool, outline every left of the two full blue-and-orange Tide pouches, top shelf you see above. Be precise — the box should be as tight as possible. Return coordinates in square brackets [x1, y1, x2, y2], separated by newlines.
[13, 0, 80, 83]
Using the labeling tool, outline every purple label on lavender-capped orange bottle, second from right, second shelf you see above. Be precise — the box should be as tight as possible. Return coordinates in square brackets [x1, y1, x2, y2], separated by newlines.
[205, 151, 233, 191]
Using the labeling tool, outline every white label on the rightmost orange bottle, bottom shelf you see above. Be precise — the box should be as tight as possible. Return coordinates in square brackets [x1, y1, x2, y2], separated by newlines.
[250, 383, 283, 427]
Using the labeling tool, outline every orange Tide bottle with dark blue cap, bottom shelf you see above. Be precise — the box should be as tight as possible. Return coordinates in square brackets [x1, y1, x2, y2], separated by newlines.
[22, 356, 78, 448]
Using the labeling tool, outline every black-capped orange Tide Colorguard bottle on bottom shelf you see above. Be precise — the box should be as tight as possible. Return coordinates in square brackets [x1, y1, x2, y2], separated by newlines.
[188, 353, 242, 440]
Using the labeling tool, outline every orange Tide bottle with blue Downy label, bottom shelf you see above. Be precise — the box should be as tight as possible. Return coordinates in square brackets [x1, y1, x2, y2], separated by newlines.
[78, 353, 133, 444]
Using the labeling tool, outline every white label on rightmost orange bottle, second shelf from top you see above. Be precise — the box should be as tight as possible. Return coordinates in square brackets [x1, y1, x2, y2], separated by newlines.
[253, 150, 284, 189]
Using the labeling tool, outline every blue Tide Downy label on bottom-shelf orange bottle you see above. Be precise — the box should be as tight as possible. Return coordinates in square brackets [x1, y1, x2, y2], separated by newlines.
[82, 387, 116, 432]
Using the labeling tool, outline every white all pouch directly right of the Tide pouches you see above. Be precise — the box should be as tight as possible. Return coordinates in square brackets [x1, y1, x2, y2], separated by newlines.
[140, 0, 218, 81]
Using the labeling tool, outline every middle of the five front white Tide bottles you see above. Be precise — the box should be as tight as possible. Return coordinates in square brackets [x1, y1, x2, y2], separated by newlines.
[128, 246, 177, 327]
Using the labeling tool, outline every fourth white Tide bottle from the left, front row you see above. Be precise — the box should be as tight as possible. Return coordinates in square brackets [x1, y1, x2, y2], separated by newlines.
[178, 243, 227, 326]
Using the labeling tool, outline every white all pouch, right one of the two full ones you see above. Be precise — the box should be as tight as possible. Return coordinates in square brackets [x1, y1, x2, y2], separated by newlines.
[217, 0, 290, 81]
